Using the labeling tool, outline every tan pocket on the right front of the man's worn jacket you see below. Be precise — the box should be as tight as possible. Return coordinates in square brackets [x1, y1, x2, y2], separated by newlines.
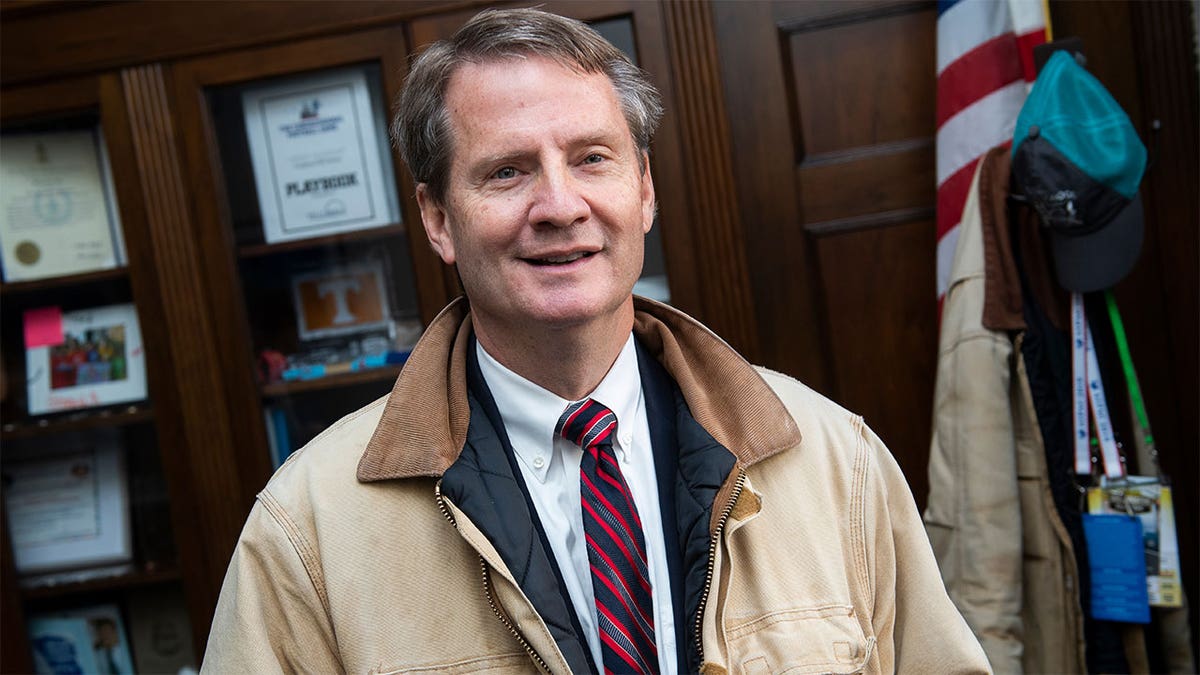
[726, 605, 875, 675]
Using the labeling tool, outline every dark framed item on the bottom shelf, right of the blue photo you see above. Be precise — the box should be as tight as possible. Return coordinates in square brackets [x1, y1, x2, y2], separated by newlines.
[125, 587, 199, 673]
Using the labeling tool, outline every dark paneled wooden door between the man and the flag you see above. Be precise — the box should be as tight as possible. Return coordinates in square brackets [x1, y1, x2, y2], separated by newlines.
[713, 0, 937, 494]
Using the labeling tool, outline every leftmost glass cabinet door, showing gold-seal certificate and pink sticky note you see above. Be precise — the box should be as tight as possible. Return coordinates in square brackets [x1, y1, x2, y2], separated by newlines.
[0, 77, 198, 673]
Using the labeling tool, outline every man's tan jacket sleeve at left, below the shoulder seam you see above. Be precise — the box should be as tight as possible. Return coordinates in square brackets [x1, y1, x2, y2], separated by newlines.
[200, 492, 344, 674]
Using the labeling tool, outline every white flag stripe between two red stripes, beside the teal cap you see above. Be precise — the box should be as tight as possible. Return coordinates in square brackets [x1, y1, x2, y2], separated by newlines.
[937, 79, 1026, 185]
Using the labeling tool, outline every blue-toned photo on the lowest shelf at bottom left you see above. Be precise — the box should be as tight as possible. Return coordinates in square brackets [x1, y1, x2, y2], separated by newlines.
[29, 604, 134, 675]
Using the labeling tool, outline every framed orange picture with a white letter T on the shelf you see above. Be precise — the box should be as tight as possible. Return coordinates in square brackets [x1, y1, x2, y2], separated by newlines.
[292, 261, 391, 340]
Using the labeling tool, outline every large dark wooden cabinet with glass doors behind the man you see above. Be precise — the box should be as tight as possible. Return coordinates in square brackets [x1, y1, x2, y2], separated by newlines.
[0, 0, 756, 671]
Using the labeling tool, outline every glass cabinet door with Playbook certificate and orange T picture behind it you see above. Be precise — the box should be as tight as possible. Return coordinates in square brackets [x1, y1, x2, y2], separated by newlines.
[176, 24, 450, 468]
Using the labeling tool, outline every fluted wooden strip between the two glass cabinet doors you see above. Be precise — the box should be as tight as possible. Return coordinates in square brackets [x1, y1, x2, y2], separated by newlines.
[114, 66, 255, 647]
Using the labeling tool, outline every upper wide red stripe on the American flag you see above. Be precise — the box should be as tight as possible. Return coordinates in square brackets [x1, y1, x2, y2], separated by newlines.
[937, 32, 1022, 127]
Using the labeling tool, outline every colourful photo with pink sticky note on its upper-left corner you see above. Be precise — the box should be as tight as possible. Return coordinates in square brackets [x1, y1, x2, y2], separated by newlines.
[24, 304, 146, 414]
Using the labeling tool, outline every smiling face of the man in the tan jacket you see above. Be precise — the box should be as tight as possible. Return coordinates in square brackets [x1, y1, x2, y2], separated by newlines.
[418, 58, 654, 336]
